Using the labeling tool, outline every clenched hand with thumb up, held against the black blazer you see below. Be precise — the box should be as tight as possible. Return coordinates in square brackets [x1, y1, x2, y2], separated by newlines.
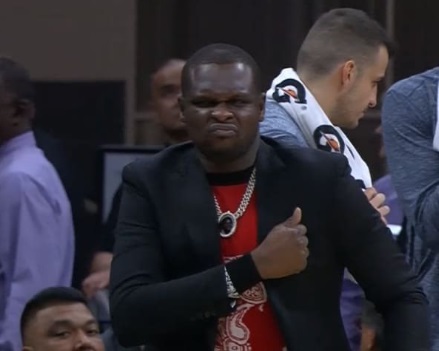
[251, 208, 309, 279]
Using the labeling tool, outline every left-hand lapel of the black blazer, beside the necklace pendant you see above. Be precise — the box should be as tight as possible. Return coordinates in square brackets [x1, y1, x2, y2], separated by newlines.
[173, 150, 222, 270]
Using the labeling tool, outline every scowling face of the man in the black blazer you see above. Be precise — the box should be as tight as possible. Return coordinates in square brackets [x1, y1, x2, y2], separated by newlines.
[180, 63, 264, 162]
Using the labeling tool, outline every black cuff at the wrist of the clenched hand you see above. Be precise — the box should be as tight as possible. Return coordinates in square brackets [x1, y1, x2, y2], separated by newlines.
[226, 254, 262, 294]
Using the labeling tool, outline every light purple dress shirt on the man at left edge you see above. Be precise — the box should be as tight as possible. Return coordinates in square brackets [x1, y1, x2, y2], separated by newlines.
[0, 132, 74, 351]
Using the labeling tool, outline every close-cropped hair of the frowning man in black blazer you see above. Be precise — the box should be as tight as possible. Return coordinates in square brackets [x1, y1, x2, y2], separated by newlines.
[181, 43, 262, 96]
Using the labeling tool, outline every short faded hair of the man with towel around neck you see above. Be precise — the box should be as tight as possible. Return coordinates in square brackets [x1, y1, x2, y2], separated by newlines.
[297, 8, 395, 77]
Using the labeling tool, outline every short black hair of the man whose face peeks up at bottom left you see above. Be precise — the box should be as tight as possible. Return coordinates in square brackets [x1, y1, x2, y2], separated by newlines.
[20, 287, 87, 338]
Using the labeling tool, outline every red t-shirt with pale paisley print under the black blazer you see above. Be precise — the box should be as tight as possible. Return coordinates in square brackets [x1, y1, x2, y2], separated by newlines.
[212, 184, 284, 351]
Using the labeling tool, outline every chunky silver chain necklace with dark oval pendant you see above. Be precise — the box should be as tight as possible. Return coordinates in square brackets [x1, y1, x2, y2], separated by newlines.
[213, 168, 256, 238]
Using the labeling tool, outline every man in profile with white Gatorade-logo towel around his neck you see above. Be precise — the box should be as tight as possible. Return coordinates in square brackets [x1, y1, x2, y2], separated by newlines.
[261, 9, 392, 351]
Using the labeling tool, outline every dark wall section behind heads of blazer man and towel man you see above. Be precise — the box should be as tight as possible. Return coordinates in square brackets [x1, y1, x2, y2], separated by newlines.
[136, 0, 387, 178]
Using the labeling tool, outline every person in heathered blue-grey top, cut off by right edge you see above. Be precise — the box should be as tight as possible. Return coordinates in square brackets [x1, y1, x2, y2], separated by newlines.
[382, 67, 439, 351]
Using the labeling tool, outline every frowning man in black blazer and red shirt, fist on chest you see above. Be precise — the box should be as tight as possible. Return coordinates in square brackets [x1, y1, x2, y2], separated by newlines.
[110, 44, 429, 351]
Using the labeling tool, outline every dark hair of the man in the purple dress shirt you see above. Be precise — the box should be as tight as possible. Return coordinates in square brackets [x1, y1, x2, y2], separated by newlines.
[0, 57, 35, 102]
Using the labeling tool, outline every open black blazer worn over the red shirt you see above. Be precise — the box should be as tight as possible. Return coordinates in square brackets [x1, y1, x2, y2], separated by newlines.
[110, 139, 429, 351]
